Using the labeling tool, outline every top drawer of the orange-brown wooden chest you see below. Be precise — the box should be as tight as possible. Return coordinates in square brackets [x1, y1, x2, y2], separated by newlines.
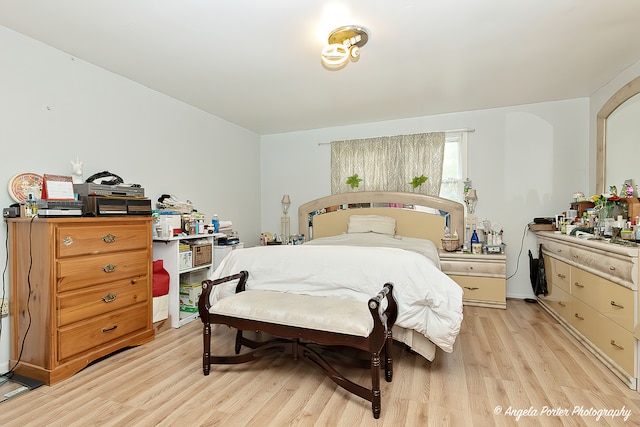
[56, 224, 149, 258]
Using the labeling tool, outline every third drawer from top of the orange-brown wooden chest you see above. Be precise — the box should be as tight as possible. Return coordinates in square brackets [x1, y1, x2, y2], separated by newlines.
[58, 277, 149, 326]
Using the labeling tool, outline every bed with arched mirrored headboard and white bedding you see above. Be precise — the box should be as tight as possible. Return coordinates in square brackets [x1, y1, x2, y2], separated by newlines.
[211, 192, 464, 361]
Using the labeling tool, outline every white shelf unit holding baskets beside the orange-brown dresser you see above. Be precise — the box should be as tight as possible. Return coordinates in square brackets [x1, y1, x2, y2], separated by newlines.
[153, 234, 215, 328]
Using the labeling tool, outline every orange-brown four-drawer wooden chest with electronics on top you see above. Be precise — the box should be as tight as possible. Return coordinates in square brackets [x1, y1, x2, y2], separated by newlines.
[8, 217, 154, 385]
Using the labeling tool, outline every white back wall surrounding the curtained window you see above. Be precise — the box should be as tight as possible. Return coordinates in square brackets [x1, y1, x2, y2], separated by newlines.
[261, 98, 589, 298]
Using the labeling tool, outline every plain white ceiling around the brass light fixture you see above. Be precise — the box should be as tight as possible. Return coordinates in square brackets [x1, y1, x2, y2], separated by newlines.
[0, 0, 640, 135]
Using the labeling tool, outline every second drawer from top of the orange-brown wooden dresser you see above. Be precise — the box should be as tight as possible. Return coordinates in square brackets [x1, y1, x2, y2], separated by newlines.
[56, 250, 150, 292]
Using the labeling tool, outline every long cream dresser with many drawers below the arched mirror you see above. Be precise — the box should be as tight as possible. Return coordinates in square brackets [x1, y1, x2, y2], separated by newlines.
[536, 232, 640, 390]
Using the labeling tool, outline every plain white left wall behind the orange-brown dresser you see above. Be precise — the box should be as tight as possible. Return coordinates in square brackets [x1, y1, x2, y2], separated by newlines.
[0, 26, 260, 372]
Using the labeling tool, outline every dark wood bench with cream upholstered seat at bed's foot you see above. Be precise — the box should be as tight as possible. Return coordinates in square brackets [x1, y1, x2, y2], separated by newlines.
[198, 271, 397, 418]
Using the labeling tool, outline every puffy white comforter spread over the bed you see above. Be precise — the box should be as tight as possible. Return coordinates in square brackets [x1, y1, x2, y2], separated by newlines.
[211, 244, 462, 353]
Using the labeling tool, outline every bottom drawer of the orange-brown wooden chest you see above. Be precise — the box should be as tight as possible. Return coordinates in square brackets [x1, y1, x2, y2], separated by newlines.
[58, 304, 149, 361]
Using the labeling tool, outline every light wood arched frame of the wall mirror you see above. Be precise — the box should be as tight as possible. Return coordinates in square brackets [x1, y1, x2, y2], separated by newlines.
[595, 76, 640, 194]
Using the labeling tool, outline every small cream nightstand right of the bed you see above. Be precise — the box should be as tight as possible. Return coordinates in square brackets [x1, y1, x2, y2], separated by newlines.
[440, 251, 507, 309]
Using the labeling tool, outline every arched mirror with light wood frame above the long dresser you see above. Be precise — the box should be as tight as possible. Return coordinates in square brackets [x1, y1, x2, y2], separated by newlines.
[596, 77, 640, 194]
